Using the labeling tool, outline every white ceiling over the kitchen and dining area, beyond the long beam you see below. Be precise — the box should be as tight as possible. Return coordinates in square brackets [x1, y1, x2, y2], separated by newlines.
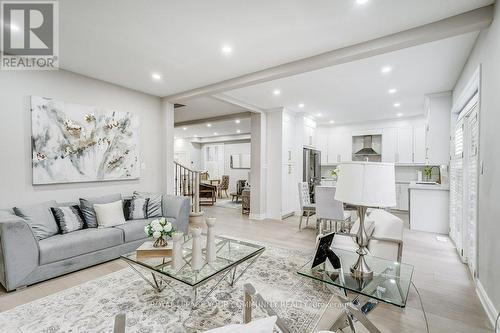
[225, 33, 478, 124]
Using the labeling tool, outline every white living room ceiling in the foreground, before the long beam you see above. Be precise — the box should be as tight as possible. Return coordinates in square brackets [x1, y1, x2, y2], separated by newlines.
[59, 0, 494, 96]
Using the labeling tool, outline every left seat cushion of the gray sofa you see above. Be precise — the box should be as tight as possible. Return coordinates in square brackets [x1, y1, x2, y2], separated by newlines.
[39, 228, 123, 265]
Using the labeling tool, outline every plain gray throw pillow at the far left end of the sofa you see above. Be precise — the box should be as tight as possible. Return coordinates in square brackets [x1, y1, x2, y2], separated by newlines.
[14, 200, 59, 240]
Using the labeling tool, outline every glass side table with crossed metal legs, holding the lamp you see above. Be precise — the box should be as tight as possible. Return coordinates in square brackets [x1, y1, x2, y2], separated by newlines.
[297, 248, 413, 333]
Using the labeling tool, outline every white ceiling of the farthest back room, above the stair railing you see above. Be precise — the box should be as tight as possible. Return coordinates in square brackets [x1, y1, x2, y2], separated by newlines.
[174, 116, 250, 138]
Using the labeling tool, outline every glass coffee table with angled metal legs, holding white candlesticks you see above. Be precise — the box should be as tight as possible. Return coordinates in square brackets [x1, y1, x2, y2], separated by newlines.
[121, 235, 266, 309]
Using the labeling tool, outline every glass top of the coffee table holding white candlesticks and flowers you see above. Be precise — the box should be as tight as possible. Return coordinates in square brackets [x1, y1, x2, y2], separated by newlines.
[121, 235, 265, 286]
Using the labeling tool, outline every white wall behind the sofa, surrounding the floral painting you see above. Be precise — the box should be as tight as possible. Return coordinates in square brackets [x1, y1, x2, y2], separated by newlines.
[0, 70, 164, 208]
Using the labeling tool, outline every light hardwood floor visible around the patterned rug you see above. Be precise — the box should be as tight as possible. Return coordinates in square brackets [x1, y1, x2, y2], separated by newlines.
[0, 207, 493, 333]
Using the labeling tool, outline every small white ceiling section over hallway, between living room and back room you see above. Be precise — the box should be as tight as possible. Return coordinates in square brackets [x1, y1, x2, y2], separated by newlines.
[174, 97, 247, 123]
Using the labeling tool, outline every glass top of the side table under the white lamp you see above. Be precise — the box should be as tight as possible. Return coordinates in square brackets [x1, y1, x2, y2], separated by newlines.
[297, 248, 413, 308]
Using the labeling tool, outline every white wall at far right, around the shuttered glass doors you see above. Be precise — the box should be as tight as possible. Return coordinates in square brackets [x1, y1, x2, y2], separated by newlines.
[453, 4, 500, 320]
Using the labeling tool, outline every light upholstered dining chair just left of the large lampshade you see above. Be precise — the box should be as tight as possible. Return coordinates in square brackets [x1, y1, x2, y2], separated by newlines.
[314, 186, 351, 234]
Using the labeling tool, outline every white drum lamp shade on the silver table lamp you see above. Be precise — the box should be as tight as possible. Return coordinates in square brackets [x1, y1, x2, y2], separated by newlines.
[335, 162, 396, 207]
